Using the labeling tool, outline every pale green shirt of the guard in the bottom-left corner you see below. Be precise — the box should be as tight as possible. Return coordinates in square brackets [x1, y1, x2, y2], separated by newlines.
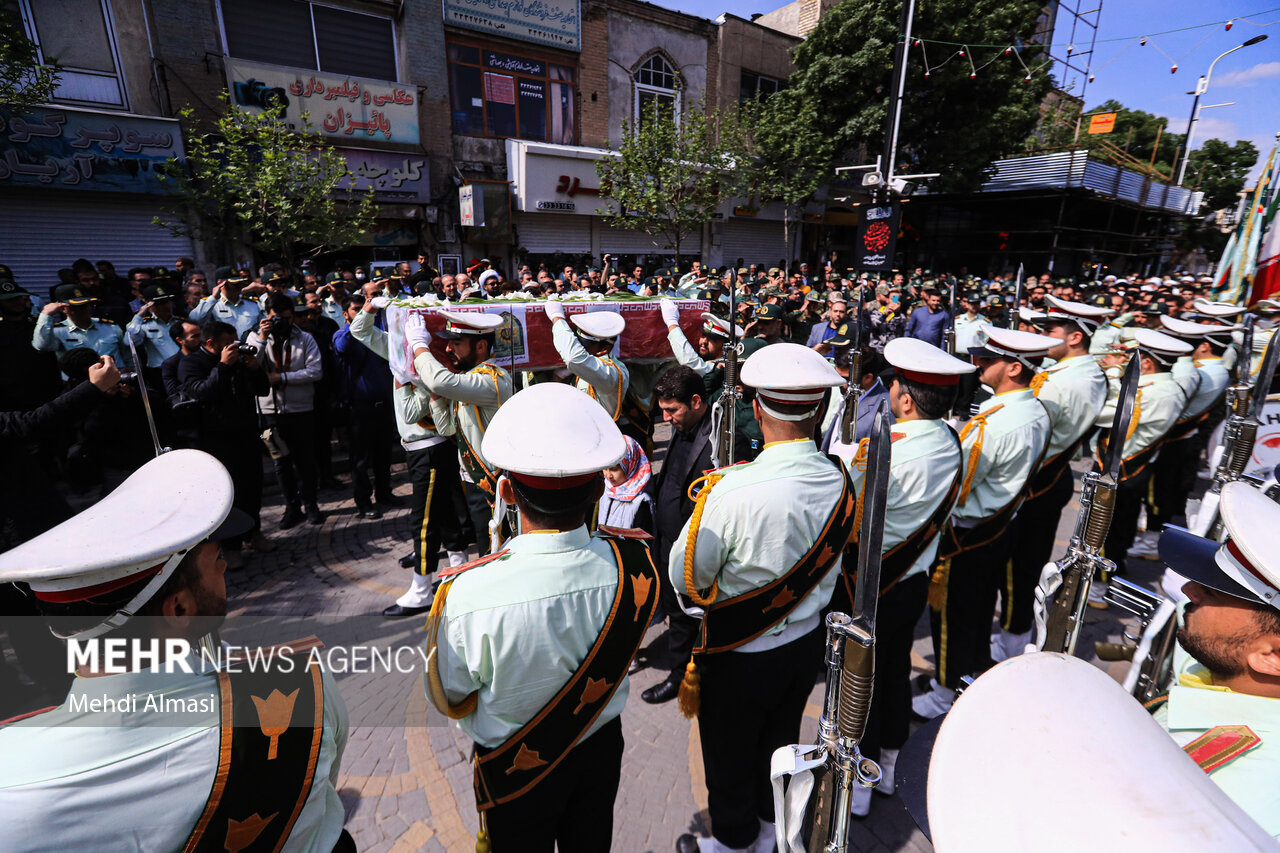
[0, 662, 347, 853]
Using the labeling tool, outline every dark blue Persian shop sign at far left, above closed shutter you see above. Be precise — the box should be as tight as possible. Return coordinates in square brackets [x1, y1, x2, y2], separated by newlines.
[0, 108, 183, 192]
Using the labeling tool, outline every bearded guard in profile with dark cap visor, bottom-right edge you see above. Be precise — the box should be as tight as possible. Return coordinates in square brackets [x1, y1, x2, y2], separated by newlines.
[1148, 483, 1280, 836]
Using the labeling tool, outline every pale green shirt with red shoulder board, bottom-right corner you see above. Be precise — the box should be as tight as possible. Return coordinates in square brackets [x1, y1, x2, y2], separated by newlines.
[1155, 660, 1280, 838]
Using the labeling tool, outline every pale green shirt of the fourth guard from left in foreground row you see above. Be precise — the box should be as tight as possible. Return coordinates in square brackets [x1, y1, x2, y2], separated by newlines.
[951, 388, 1050, 528]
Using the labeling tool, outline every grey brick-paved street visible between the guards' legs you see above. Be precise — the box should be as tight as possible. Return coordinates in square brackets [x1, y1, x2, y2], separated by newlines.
[209, 448, 1155, 853]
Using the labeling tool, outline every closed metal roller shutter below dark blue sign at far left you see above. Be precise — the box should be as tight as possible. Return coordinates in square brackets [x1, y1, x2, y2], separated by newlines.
[0, 190, 194, 297]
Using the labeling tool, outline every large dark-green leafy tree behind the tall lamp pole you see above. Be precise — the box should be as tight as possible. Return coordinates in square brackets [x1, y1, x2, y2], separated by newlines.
[787, 0, 1052, 192]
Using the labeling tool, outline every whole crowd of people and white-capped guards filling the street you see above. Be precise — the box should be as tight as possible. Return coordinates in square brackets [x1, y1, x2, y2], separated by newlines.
[0, 249, 1280, 853]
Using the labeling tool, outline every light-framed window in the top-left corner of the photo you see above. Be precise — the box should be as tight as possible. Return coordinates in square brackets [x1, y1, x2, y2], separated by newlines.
[20, 0, 128, 109]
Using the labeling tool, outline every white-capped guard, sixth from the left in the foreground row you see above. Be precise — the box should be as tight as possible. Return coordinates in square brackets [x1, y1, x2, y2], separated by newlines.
[1089, 328, 1192, 578]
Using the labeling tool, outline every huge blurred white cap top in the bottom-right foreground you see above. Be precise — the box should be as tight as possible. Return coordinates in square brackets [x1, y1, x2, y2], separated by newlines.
[928, 652, 1275, 853]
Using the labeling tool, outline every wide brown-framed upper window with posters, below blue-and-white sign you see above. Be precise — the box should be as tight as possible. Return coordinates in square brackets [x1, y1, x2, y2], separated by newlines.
[449, 44, 577, 145]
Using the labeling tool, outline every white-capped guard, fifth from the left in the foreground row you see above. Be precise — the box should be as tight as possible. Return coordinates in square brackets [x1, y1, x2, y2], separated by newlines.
[991, 293, 1111, 662]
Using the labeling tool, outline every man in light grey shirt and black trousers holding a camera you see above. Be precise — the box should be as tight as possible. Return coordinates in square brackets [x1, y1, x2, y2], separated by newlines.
[244, 293, 324, 530]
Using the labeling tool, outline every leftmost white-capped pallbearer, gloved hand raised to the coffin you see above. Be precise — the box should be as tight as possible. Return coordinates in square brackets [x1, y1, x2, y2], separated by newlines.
[404, 310, 511, 558]
